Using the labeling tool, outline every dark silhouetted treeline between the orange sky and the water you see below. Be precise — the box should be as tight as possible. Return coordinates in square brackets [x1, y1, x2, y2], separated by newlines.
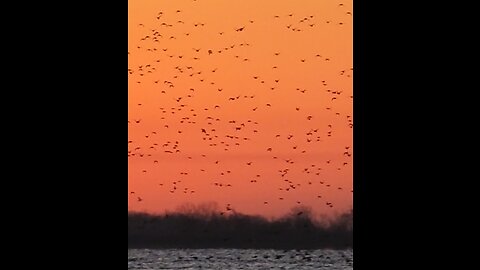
[128, 205, 353, 249]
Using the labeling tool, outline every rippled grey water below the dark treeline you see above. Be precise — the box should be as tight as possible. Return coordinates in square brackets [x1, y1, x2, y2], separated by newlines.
[128, 249, 353, 270]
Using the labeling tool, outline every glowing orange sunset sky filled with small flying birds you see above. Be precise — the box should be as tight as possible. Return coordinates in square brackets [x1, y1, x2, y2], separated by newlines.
[128, 0, 353, 219]
